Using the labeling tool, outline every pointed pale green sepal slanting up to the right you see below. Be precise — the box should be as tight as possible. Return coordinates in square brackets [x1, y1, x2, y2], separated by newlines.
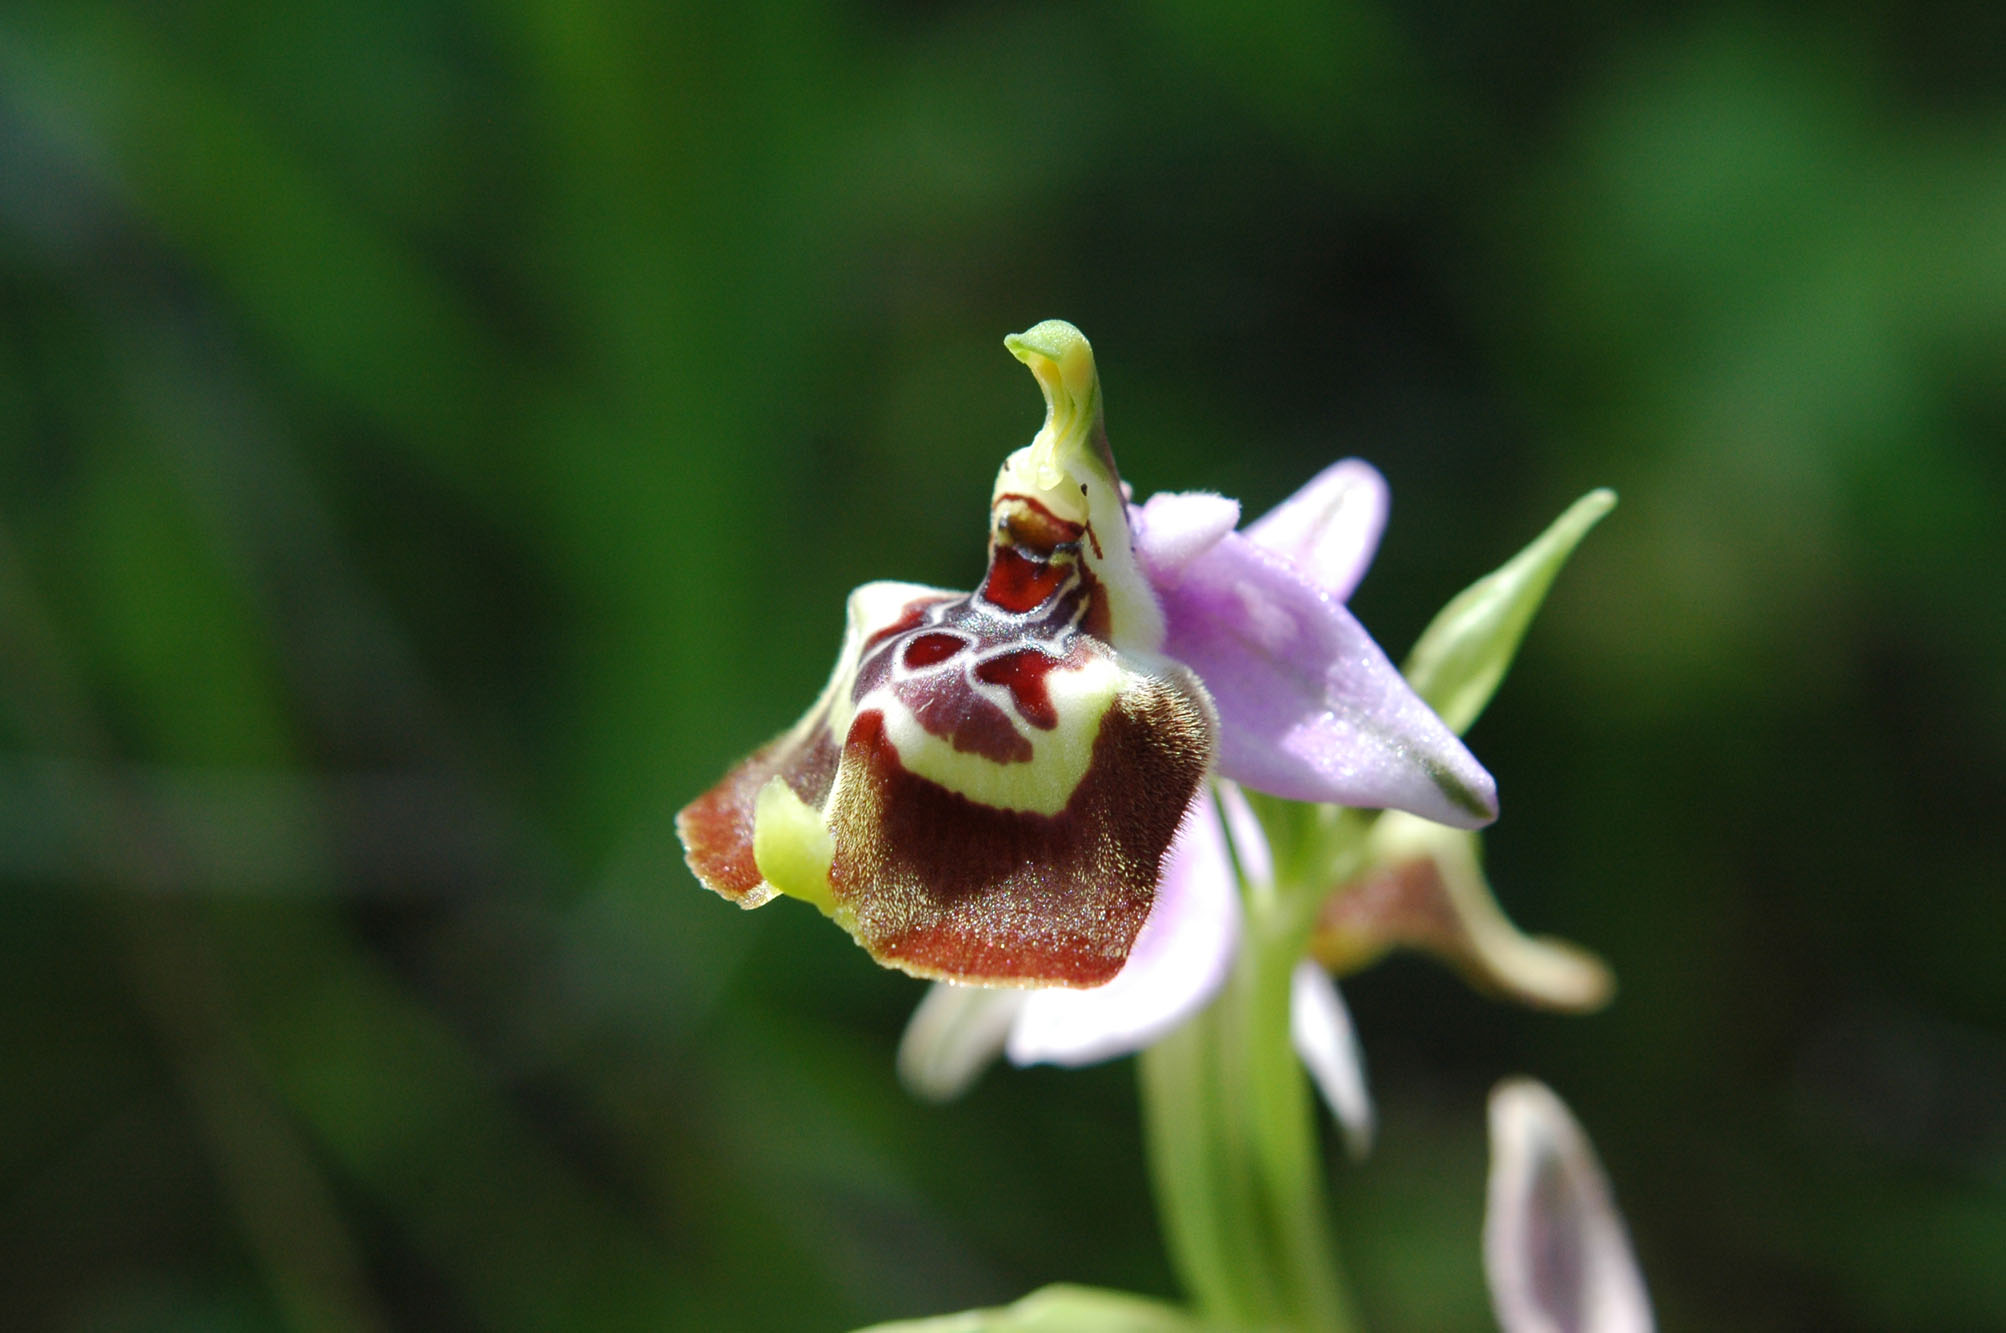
[1402, 487, 1617, 736]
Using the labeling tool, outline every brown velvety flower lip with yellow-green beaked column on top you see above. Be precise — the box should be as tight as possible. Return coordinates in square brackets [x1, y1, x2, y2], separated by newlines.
[678, 321, 1218, 986]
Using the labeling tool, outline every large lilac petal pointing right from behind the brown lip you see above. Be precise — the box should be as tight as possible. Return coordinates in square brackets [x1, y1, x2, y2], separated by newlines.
[1137, 533, 1496, 828]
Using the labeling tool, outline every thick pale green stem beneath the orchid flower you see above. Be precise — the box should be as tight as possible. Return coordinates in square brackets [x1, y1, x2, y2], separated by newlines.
[1141, 793, 1370, 1333]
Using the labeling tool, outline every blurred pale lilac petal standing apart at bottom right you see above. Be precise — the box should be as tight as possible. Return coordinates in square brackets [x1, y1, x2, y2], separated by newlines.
[1484, 1078, 1653, 1333]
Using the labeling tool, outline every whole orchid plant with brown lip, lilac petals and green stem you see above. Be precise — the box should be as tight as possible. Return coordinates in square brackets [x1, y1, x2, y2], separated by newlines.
[676, 321, 1647, 1333]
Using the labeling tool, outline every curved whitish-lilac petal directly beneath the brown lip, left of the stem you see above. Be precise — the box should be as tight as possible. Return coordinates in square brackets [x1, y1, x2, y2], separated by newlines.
[1007, 792, 1240, 1064]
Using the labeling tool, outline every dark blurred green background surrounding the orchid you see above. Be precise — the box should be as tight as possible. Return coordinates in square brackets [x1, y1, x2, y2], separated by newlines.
[0, 0, 2006, 1331]
